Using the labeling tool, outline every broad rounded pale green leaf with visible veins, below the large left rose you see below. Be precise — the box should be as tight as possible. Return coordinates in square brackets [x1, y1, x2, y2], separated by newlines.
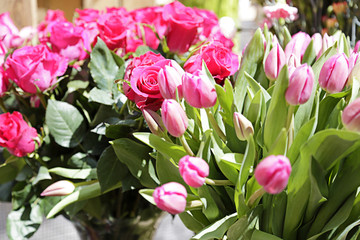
[45, 100, 86, 148]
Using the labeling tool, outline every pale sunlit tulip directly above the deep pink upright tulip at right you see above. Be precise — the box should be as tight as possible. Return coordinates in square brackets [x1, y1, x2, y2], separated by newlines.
[285, 32, 311, 60]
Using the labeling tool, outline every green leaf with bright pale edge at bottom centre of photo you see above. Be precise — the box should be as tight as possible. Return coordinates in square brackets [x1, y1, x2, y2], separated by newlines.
[192, 213, 237, 240]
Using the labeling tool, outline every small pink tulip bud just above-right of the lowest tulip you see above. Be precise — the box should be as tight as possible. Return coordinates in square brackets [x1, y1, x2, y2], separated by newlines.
[179, 156, 209, 188]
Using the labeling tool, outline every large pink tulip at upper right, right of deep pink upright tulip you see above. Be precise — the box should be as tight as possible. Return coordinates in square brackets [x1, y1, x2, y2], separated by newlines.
[319, 53, 349, 93]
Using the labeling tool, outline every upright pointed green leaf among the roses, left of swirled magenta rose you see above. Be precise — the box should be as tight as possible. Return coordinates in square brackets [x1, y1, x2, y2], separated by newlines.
[89, 37, 119, 92]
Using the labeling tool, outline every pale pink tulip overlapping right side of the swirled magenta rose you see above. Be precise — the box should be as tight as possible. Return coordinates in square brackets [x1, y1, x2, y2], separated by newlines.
[158, 60, 185, 99]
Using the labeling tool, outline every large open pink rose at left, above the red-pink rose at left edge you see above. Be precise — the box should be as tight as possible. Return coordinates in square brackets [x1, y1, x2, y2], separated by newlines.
[6, 45, 67, 93]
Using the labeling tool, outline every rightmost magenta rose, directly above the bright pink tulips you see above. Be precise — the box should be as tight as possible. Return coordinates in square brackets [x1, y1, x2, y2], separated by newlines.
[184, 42, 239, 84]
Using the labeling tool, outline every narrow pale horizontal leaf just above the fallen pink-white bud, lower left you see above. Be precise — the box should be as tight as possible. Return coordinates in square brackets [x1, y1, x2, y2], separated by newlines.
[49, 167, 97, 179]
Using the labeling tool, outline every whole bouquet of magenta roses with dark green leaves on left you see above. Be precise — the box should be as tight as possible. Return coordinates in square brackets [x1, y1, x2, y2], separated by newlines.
[0, 2, 239, 239]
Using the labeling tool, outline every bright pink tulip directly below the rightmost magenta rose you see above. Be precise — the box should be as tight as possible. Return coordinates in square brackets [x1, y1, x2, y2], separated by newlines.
[182, 70, 217, 108]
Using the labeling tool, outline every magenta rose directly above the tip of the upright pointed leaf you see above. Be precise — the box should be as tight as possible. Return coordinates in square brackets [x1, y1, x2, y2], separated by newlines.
[97, 10, 134, 50]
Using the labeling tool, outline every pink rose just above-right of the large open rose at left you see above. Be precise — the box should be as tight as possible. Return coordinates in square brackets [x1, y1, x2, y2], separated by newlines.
[49, 22, 91, 61]
